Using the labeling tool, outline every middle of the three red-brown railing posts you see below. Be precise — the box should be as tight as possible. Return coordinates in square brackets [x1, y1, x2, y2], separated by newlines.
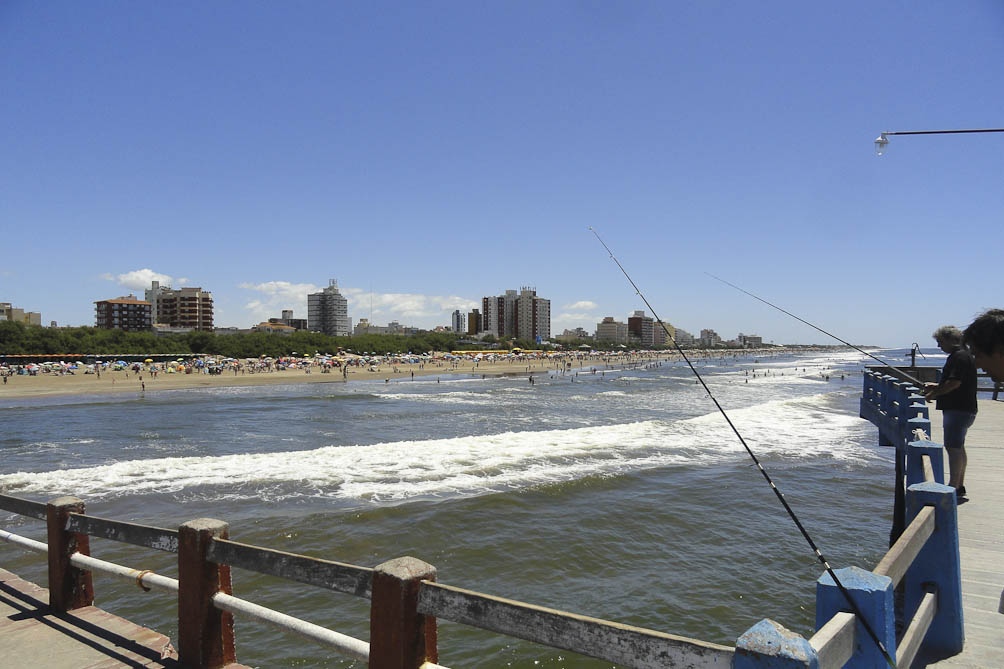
[178, 518, 237, 669]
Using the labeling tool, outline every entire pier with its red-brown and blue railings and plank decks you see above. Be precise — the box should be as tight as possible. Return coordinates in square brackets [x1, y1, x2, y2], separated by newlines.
[0, 375, 1004, 669]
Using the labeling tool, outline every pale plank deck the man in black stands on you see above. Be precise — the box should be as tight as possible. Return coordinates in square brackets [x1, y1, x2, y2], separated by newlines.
[914, 399, 1004, 669]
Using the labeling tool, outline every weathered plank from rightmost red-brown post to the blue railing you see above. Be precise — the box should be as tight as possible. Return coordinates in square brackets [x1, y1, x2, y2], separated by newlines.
[419, 582, 735, 669]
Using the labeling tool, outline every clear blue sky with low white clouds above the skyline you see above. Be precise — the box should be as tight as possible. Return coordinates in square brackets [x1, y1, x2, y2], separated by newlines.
[0, 5, 1004, 348]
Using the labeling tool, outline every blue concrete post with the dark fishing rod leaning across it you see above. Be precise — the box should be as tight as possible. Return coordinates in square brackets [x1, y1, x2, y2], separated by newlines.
[815, 567, 896, 669]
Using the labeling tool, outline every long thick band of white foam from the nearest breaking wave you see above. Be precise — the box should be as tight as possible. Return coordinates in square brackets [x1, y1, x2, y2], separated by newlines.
[0, 395, 873, 501]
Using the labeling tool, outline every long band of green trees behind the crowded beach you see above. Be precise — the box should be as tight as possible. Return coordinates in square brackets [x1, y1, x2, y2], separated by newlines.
[0, 320, 570, 358]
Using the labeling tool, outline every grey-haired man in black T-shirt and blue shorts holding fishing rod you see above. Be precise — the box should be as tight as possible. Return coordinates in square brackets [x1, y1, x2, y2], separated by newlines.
[924, 325, 978, 498]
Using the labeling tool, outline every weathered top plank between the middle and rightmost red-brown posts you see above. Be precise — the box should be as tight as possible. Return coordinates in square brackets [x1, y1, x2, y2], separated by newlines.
[207, 538, 373, 599]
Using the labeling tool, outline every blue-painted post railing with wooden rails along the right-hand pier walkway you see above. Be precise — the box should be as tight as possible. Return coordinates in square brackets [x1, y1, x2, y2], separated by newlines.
[733, 372, 965, 669]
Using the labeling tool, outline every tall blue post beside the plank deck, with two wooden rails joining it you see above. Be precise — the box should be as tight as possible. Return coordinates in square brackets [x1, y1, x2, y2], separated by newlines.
[904, 482, 966, 655]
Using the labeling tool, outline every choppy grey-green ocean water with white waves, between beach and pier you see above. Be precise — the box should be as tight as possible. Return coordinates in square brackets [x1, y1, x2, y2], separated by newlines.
[0, 350, 903, 667]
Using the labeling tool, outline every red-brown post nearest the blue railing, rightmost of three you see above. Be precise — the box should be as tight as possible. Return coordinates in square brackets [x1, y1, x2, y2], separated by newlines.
[369, 558, 439, 669]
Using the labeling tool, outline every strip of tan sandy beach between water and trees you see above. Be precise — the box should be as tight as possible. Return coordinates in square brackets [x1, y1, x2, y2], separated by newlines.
[0, 354, 677, 399]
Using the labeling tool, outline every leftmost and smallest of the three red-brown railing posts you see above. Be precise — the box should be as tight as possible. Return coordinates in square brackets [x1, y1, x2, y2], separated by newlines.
[45, 497, 94, 613]
